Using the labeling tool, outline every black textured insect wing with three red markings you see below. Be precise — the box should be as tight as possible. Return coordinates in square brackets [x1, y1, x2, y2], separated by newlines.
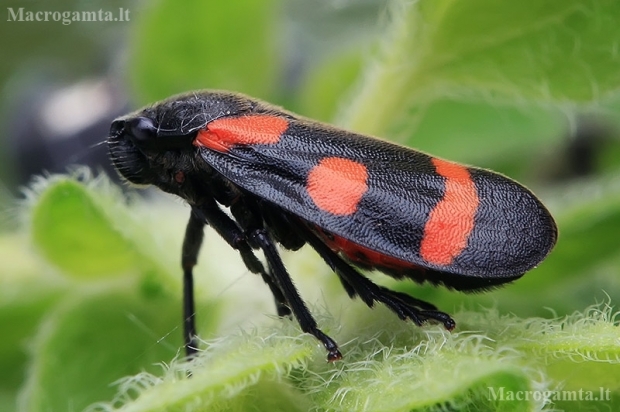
[195, 114, 556, 278]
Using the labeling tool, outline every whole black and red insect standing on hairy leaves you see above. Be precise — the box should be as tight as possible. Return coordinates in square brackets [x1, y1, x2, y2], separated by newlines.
[108, 91, 557, 360]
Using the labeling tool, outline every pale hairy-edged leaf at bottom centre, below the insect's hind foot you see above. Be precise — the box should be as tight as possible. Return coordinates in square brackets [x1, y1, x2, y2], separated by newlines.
[302, 330, 534, 412]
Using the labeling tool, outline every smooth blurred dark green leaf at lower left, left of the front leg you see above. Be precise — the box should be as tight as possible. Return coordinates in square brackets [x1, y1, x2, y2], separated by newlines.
[21, 283, 188, 412]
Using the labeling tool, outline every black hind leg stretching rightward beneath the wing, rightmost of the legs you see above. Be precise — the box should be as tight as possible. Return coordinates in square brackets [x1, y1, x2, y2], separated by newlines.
[303, 230, 455, 330]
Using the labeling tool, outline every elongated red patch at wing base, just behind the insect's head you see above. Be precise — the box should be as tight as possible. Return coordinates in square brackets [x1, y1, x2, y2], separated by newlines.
[194, 115, 288, 152]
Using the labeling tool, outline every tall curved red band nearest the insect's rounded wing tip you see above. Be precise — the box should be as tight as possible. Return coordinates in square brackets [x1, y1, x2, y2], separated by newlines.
[420, 158, 479, 265]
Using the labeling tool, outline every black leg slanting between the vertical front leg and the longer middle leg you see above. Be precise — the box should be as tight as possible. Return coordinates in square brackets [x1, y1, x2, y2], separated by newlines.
[196, 202, 291, 316]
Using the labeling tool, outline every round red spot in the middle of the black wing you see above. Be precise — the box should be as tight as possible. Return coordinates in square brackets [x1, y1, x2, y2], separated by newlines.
[307, 157, 368, 215]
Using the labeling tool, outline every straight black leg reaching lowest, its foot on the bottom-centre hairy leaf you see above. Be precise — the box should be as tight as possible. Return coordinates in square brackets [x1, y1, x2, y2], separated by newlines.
[249, 229, 342, 362]
